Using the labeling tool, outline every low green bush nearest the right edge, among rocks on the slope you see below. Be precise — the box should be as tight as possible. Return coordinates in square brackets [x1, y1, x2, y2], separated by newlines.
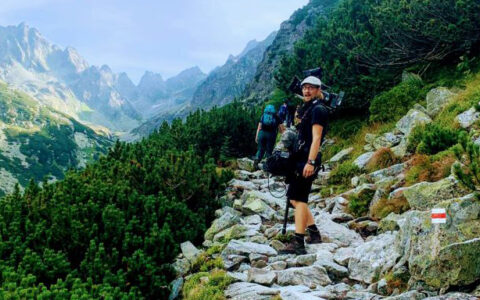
[407, 123, 458, 155]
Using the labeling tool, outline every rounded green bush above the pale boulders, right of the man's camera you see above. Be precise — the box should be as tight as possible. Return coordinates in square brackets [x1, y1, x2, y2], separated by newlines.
[370, 79, 426, 122]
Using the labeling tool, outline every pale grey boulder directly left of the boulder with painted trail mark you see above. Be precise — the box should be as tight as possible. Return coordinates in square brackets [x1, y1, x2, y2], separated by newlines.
[348, 232, 400, 283]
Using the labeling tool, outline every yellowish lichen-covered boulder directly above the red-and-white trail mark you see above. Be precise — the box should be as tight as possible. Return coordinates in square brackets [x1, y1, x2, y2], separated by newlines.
[403, 176, 468, 210]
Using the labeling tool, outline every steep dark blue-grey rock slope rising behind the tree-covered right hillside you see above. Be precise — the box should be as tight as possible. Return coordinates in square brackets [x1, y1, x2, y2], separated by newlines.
[243, 0, 338, 100]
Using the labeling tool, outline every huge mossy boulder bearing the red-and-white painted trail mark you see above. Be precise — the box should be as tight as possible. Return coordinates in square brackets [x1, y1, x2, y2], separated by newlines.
[395, 195, 480, 289]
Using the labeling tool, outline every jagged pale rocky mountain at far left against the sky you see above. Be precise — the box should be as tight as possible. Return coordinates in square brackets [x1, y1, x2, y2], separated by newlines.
[0, 23, 140, 130]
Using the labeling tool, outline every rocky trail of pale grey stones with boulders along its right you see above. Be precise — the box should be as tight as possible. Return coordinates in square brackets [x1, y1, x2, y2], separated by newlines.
[171, 85, 480, 300]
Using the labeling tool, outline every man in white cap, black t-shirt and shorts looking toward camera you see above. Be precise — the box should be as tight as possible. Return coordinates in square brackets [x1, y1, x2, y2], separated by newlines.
[282, 76, 328, 255]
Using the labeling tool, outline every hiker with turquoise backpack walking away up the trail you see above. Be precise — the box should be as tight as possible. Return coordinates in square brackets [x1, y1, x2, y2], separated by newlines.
[254, 104, 283, 170]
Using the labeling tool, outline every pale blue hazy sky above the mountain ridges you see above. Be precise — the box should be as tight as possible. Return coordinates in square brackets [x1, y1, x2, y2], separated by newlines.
[0, 0, 308, 83]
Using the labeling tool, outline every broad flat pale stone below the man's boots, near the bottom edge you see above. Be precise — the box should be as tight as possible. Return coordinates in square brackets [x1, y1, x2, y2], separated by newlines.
[277, 266, 332, 287]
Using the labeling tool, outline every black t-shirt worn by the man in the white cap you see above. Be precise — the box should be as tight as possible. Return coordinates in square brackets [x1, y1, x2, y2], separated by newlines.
[297, 100, 328, 156]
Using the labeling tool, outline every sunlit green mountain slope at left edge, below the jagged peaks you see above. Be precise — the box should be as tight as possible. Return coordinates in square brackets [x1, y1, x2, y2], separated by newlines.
[0, 82, 112, 195]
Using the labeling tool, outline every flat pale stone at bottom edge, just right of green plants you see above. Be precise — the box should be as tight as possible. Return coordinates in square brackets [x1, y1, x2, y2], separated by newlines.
[225, 282, 280, 300]
